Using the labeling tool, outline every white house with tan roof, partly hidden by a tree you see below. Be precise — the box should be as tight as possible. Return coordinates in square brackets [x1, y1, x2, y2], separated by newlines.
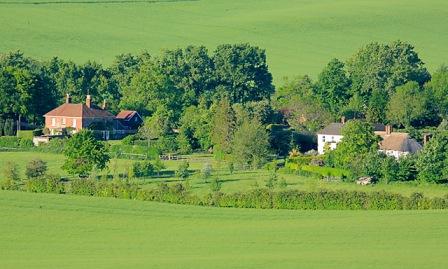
[317, 119, 422, 159]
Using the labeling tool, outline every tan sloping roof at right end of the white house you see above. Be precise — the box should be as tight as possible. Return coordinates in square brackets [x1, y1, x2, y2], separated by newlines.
[375, 132, 422, 153]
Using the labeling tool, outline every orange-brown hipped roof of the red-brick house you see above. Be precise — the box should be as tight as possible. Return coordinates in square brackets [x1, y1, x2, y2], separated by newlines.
[44, 103, 115, 118]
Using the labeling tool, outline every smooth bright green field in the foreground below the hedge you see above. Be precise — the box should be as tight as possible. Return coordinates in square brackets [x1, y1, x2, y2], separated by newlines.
[0, 191, 448, 269]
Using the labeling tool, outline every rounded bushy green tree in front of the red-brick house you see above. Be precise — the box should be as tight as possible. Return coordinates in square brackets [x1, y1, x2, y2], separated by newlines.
[62, 130, 110, 177]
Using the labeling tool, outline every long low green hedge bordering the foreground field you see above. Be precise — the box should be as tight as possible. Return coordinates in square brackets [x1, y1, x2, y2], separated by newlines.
[0, 177, 448, 210]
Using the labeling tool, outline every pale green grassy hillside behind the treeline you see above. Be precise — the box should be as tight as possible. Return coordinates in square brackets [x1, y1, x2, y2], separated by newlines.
[0, 0, 448, 82]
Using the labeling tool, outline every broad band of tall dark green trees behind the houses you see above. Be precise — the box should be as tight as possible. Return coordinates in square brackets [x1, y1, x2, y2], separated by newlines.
[0, 41, 448, 148]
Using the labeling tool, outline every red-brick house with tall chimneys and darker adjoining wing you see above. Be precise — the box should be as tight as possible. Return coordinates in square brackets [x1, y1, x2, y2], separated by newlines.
[44, 94, 141, 139]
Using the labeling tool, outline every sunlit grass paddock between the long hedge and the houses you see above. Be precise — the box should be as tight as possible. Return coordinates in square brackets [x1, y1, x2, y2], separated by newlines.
[0, 152, 448, 197]
